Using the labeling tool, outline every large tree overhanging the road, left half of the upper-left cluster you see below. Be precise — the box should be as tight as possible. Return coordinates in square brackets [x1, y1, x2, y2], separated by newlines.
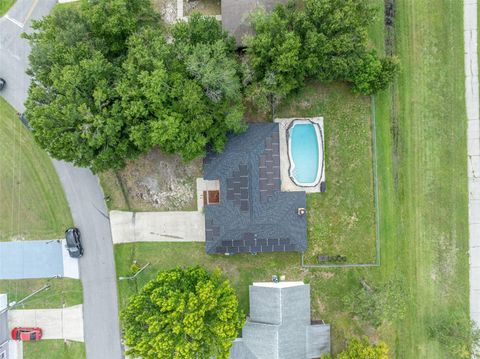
[24, 0, 156, 172]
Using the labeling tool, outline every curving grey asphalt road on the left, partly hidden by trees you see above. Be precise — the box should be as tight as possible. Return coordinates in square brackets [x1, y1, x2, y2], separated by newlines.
[0, 0, 122, 359]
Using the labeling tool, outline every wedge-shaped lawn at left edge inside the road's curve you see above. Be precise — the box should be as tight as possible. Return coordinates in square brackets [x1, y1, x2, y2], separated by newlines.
[0, 98, 72, 241]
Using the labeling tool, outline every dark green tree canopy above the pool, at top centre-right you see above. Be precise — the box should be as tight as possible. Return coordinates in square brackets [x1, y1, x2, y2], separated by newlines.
[246, 0, 397, 109]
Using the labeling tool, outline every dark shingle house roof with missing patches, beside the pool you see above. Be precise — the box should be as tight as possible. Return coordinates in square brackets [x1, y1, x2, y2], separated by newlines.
[204, 123, 307, 254]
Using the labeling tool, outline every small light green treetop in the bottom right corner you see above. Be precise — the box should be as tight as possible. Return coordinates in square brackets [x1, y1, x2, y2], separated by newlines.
[427, 308, 480, 359]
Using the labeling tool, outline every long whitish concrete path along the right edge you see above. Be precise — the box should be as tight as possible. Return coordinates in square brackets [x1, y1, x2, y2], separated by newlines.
[463, 0, 480, 326]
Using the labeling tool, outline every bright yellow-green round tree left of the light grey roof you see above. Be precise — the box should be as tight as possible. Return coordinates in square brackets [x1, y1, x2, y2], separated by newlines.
[121, 267, 244, 359]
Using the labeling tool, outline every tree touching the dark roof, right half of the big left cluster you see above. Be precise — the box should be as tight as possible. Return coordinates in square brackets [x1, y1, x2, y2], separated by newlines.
[120, 15, 245, 160]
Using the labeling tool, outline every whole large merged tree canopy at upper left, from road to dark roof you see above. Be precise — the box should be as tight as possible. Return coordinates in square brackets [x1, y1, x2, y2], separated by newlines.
[24, 0, 245, 172]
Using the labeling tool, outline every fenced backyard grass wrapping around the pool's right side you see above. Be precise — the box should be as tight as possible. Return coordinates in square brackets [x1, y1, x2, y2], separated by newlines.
[276, 81, 375, 264]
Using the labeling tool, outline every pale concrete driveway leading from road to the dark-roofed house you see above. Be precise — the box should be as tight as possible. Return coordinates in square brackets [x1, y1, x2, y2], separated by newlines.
[110, 211, 205, 243]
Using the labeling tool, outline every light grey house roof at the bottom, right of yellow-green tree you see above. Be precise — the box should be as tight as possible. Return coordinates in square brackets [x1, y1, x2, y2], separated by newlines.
[230, 282, 330, 359]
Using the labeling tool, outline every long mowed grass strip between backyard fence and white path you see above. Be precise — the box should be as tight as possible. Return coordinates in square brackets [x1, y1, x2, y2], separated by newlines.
[382, 0, 469, 358]
